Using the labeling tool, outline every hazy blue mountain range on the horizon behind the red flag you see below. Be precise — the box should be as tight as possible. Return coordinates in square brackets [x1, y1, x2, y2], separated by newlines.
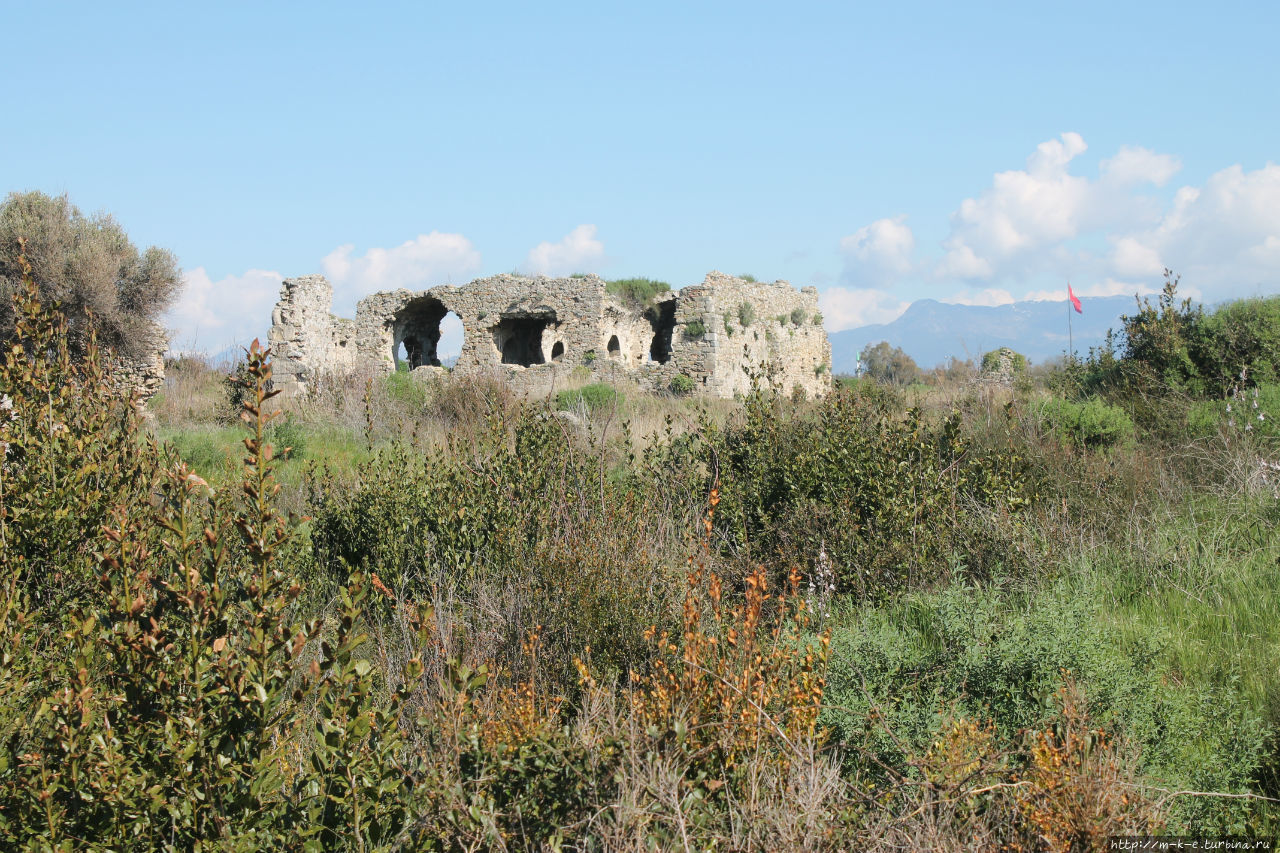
[829, 296, 1134, 373]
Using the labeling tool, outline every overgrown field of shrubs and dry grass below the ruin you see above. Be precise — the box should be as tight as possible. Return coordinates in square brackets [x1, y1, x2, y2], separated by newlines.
[0, 263, 1280, 850]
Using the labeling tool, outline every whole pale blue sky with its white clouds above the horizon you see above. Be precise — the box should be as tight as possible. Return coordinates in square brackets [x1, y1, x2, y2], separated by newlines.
[0, 1, 1280, 351]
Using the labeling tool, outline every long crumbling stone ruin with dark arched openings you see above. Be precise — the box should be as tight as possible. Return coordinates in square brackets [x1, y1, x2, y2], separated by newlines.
[268, 273, 831, 397]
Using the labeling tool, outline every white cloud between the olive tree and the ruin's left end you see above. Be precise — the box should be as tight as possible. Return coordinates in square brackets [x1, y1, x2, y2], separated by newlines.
[163, 266, 284, 355]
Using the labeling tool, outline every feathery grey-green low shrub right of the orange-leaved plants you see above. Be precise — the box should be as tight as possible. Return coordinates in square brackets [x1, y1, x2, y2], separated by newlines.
[822, 573, 1265, 831]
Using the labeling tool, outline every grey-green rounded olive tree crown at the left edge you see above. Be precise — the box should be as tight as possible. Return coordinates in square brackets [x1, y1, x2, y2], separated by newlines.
[0, 192, 182, 357]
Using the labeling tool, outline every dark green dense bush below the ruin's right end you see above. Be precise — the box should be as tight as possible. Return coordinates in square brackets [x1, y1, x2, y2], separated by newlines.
[710, 381, 1030, 598]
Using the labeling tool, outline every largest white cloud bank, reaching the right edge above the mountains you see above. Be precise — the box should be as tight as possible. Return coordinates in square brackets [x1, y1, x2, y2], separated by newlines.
[933, 133, 1280, 300]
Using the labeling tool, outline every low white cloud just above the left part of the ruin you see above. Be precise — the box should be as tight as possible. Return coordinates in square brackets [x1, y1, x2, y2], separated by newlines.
[320, 231, 480, 315]
